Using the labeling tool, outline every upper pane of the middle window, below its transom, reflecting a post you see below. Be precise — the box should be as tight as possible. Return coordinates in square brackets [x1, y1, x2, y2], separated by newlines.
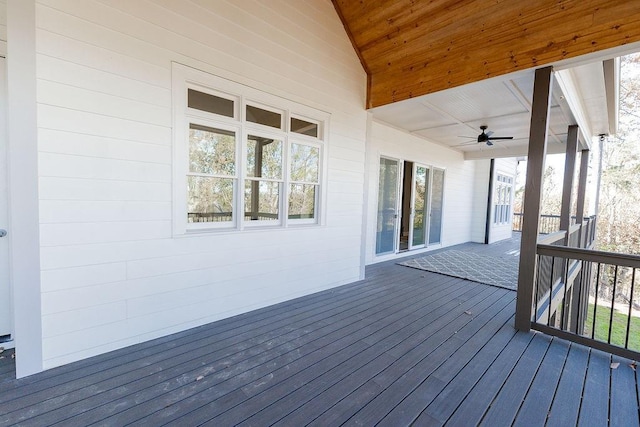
[247, 135, 282, 179]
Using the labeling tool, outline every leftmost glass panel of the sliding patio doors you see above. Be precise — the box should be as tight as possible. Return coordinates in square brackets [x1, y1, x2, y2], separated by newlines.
[376, 157, 399, 255]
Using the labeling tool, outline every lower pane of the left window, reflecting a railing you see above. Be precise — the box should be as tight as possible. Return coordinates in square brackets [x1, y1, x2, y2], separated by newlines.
[187, 176, 234, 222]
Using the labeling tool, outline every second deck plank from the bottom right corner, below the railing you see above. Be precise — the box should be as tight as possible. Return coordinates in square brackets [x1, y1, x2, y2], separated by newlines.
[578, 349, 611, 426]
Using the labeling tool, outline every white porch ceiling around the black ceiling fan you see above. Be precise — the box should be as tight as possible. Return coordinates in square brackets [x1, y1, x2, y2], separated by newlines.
[371, 57, 610, 159]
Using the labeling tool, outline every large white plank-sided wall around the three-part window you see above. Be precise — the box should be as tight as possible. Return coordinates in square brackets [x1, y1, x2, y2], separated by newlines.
[36, 0, 368, 368]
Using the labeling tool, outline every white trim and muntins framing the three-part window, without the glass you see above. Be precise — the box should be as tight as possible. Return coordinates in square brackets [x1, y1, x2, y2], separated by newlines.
[172, 62, 331, 237]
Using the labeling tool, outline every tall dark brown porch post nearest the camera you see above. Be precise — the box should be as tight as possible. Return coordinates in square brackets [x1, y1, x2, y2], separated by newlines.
[515, 67, 553, 331]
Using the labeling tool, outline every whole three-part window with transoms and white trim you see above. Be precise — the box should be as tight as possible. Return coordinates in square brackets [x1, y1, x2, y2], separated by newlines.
[173, 64, 329, 234]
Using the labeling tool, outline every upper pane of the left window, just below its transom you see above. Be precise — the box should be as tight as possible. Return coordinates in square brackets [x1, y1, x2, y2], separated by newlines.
[189, 124, 236, 176]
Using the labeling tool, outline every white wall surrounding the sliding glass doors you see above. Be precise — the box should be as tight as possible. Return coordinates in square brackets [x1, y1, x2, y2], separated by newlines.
[365, 121, 482, 264]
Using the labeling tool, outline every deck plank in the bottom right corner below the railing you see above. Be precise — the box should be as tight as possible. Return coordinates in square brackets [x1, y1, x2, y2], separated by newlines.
[609, 356, 640, 427]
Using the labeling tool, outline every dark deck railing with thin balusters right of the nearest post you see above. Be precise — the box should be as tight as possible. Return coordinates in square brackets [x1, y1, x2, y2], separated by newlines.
[532, 217, 640, 360]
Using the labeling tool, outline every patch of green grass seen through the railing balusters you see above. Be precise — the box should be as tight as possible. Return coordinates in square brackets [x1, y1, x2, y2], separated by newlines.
[585, 304, 640, 351]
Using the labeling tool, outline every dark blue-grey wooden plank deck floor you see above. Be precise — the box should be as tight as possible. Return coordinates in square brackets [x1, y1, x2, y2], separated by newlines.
[0, 263, 639, 426]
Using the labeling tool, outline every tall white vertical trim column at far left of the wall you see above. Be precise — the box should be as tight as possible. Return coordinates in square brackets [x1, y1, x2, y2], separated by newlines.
[7, 0, 42, 378]
